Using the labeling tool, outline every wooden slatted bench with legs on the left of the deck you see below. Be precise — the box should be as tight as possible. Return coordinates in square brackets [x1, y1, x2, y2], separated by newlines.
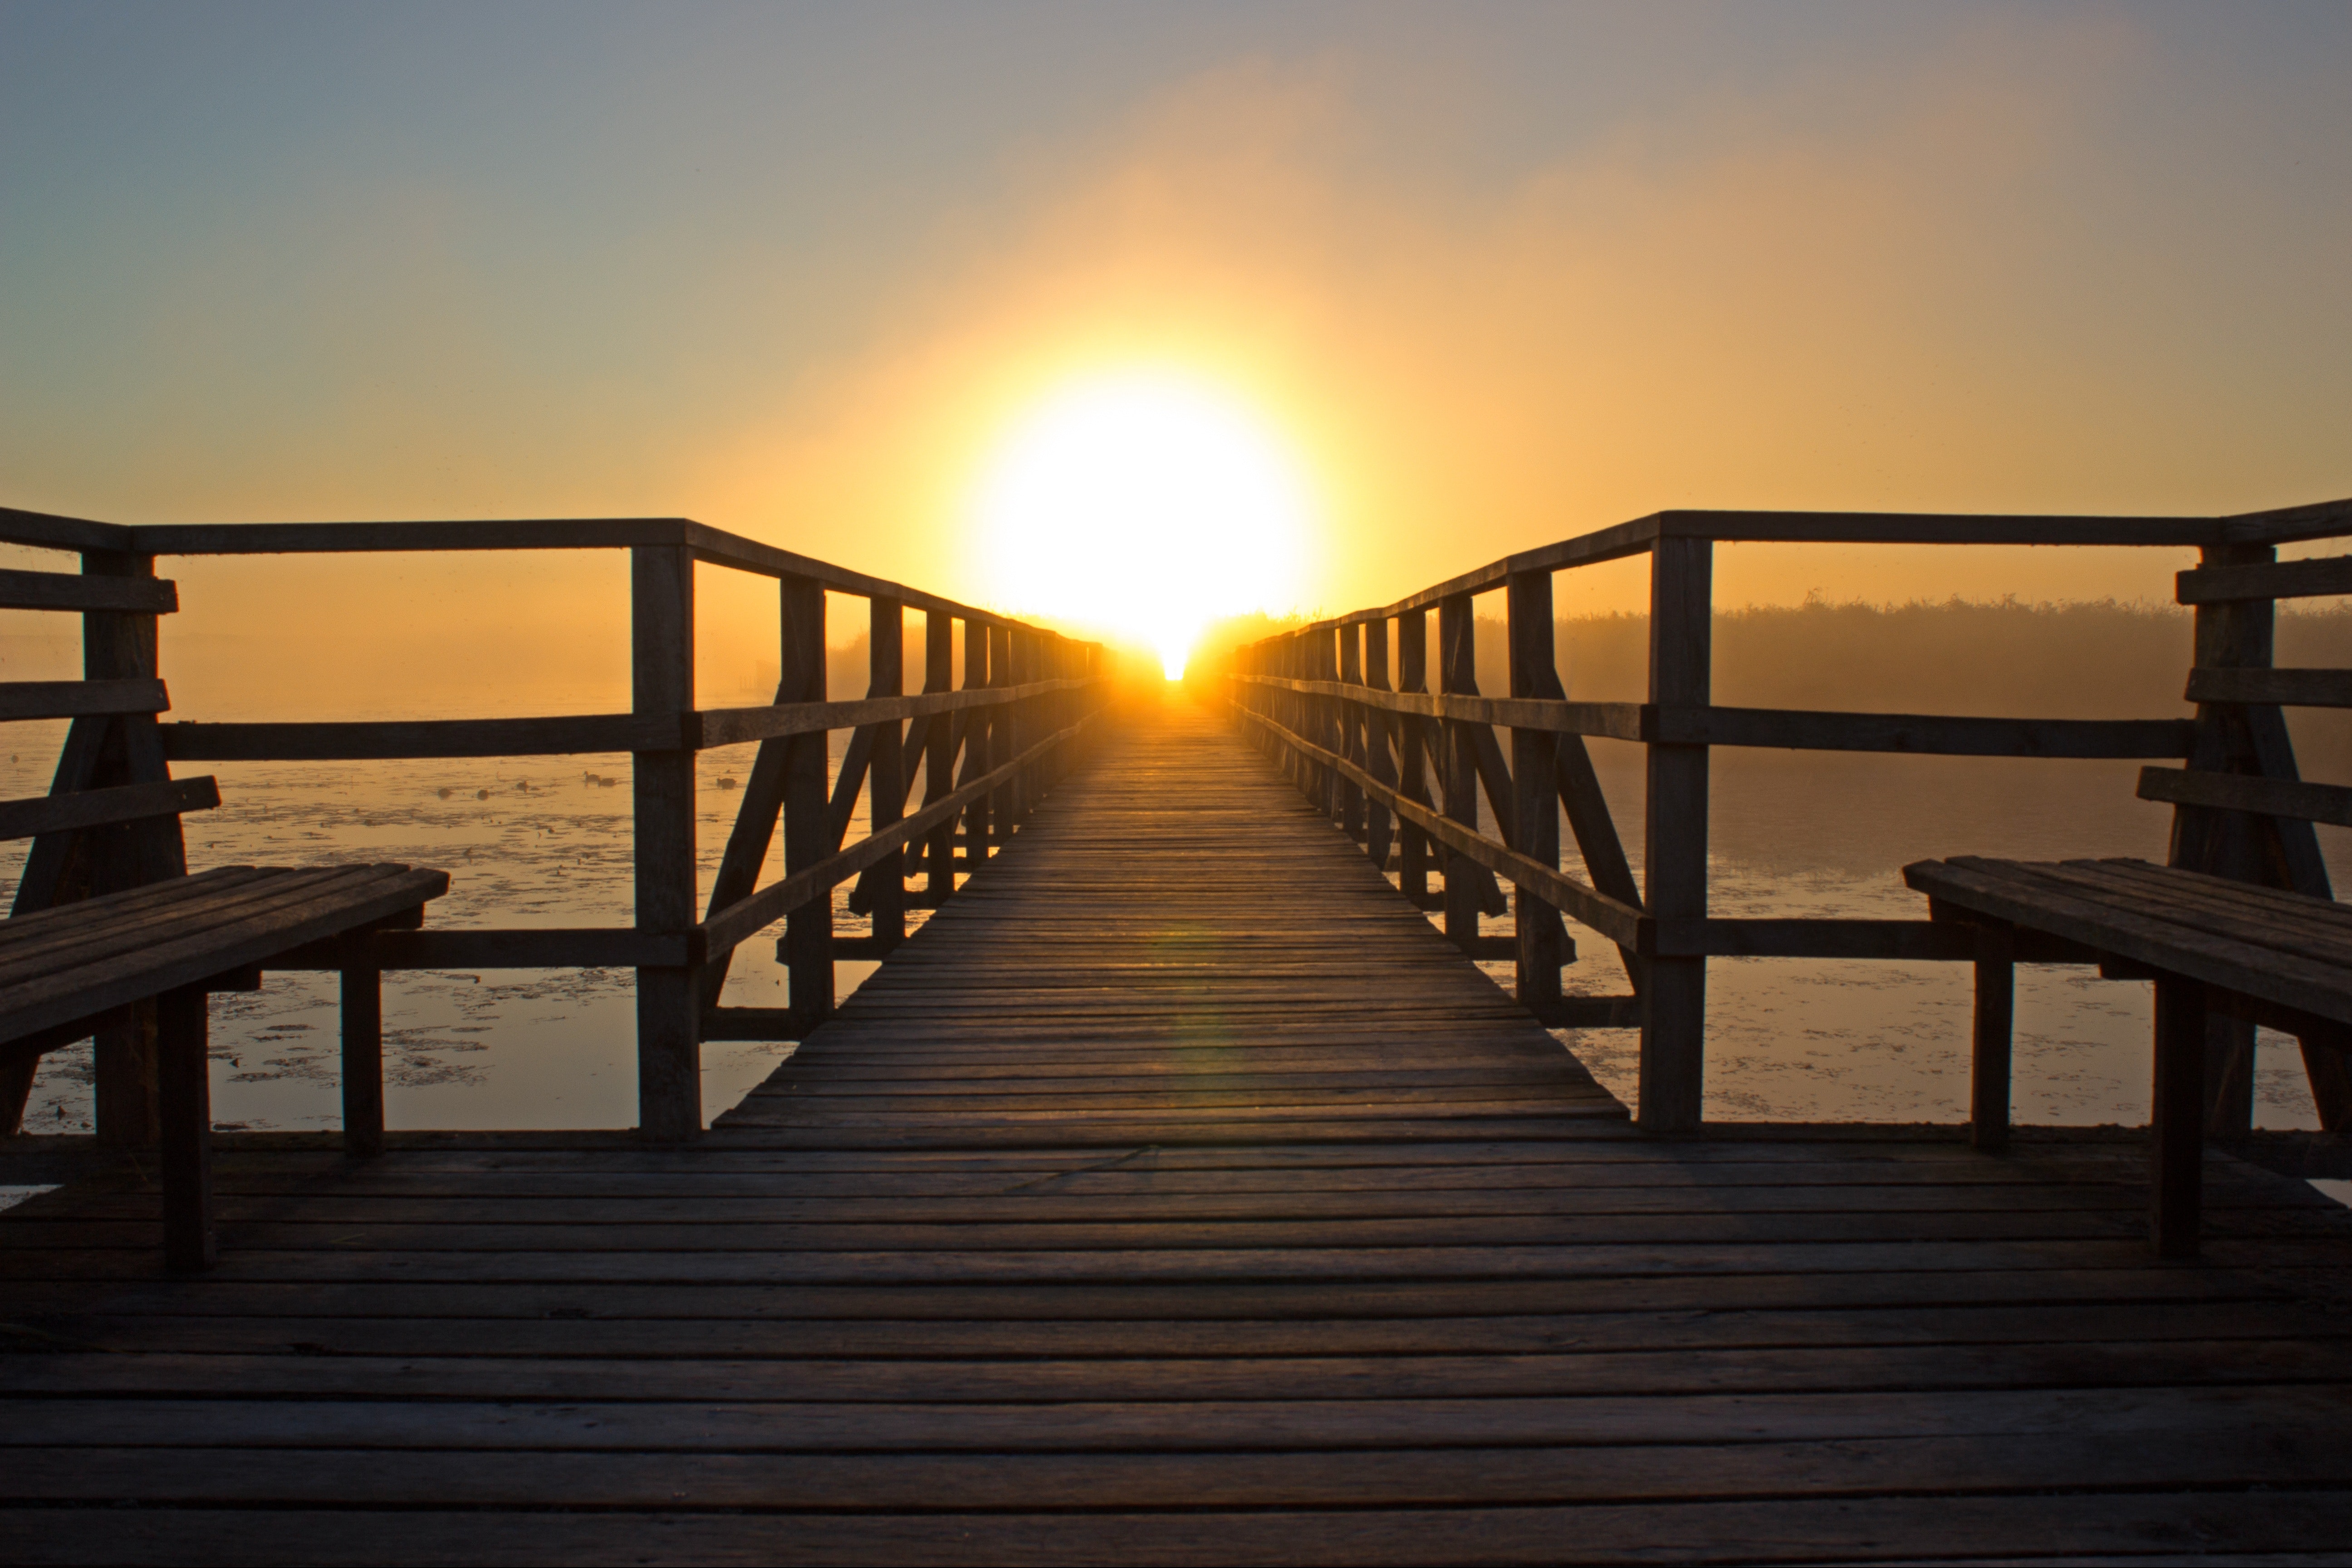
[0, 865, 449, 1269]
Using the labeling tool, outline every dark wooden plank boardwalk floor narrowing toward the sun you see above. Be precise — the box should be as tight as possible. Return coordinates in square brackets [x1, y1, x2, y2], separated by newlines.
[0, 708, 2352, 1563]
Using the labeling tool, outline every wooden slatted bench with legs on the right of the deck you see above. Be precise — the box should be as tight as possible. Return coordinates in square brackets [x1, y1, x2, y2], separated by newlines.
[1903, 856, 2352, 1258]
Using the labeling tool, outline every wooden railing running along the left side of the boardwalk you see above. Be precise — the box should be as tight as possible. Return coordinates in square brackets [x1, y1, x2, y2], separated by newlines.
[0, 508, 1108, 1140]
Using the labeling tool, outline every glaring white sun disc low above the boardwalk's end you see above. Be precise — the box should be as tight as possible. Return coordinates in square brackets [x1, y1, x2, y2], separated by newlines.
[979, 374, 1308, 679]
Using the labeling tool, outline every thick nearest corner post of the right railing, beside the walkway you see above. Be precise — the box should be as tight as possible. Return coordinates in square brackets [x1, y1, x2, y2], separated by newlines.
[1637, 539, 1715, 1133]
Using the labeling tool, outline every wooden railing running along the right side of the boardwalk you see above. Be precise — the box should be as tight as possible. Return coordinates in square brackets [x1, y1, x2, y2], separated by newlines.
[1223, 501, 2352, 1131]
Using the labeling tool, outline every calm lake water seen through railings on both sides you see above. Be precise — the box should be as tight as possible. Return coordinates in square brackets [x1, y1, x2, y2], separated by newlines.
[0, 705, 2352, 1133]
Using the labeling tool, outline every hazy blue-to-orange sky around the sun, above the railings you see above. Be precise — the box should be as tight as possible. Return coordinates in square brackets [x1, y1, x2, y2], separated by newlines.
[0, 0, 2352, 663]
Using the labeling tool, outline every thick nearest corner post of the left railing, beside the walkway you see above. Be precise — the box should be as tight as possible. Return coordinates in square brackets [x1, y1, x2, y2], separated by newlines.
[628, 545, 703, 1142]
